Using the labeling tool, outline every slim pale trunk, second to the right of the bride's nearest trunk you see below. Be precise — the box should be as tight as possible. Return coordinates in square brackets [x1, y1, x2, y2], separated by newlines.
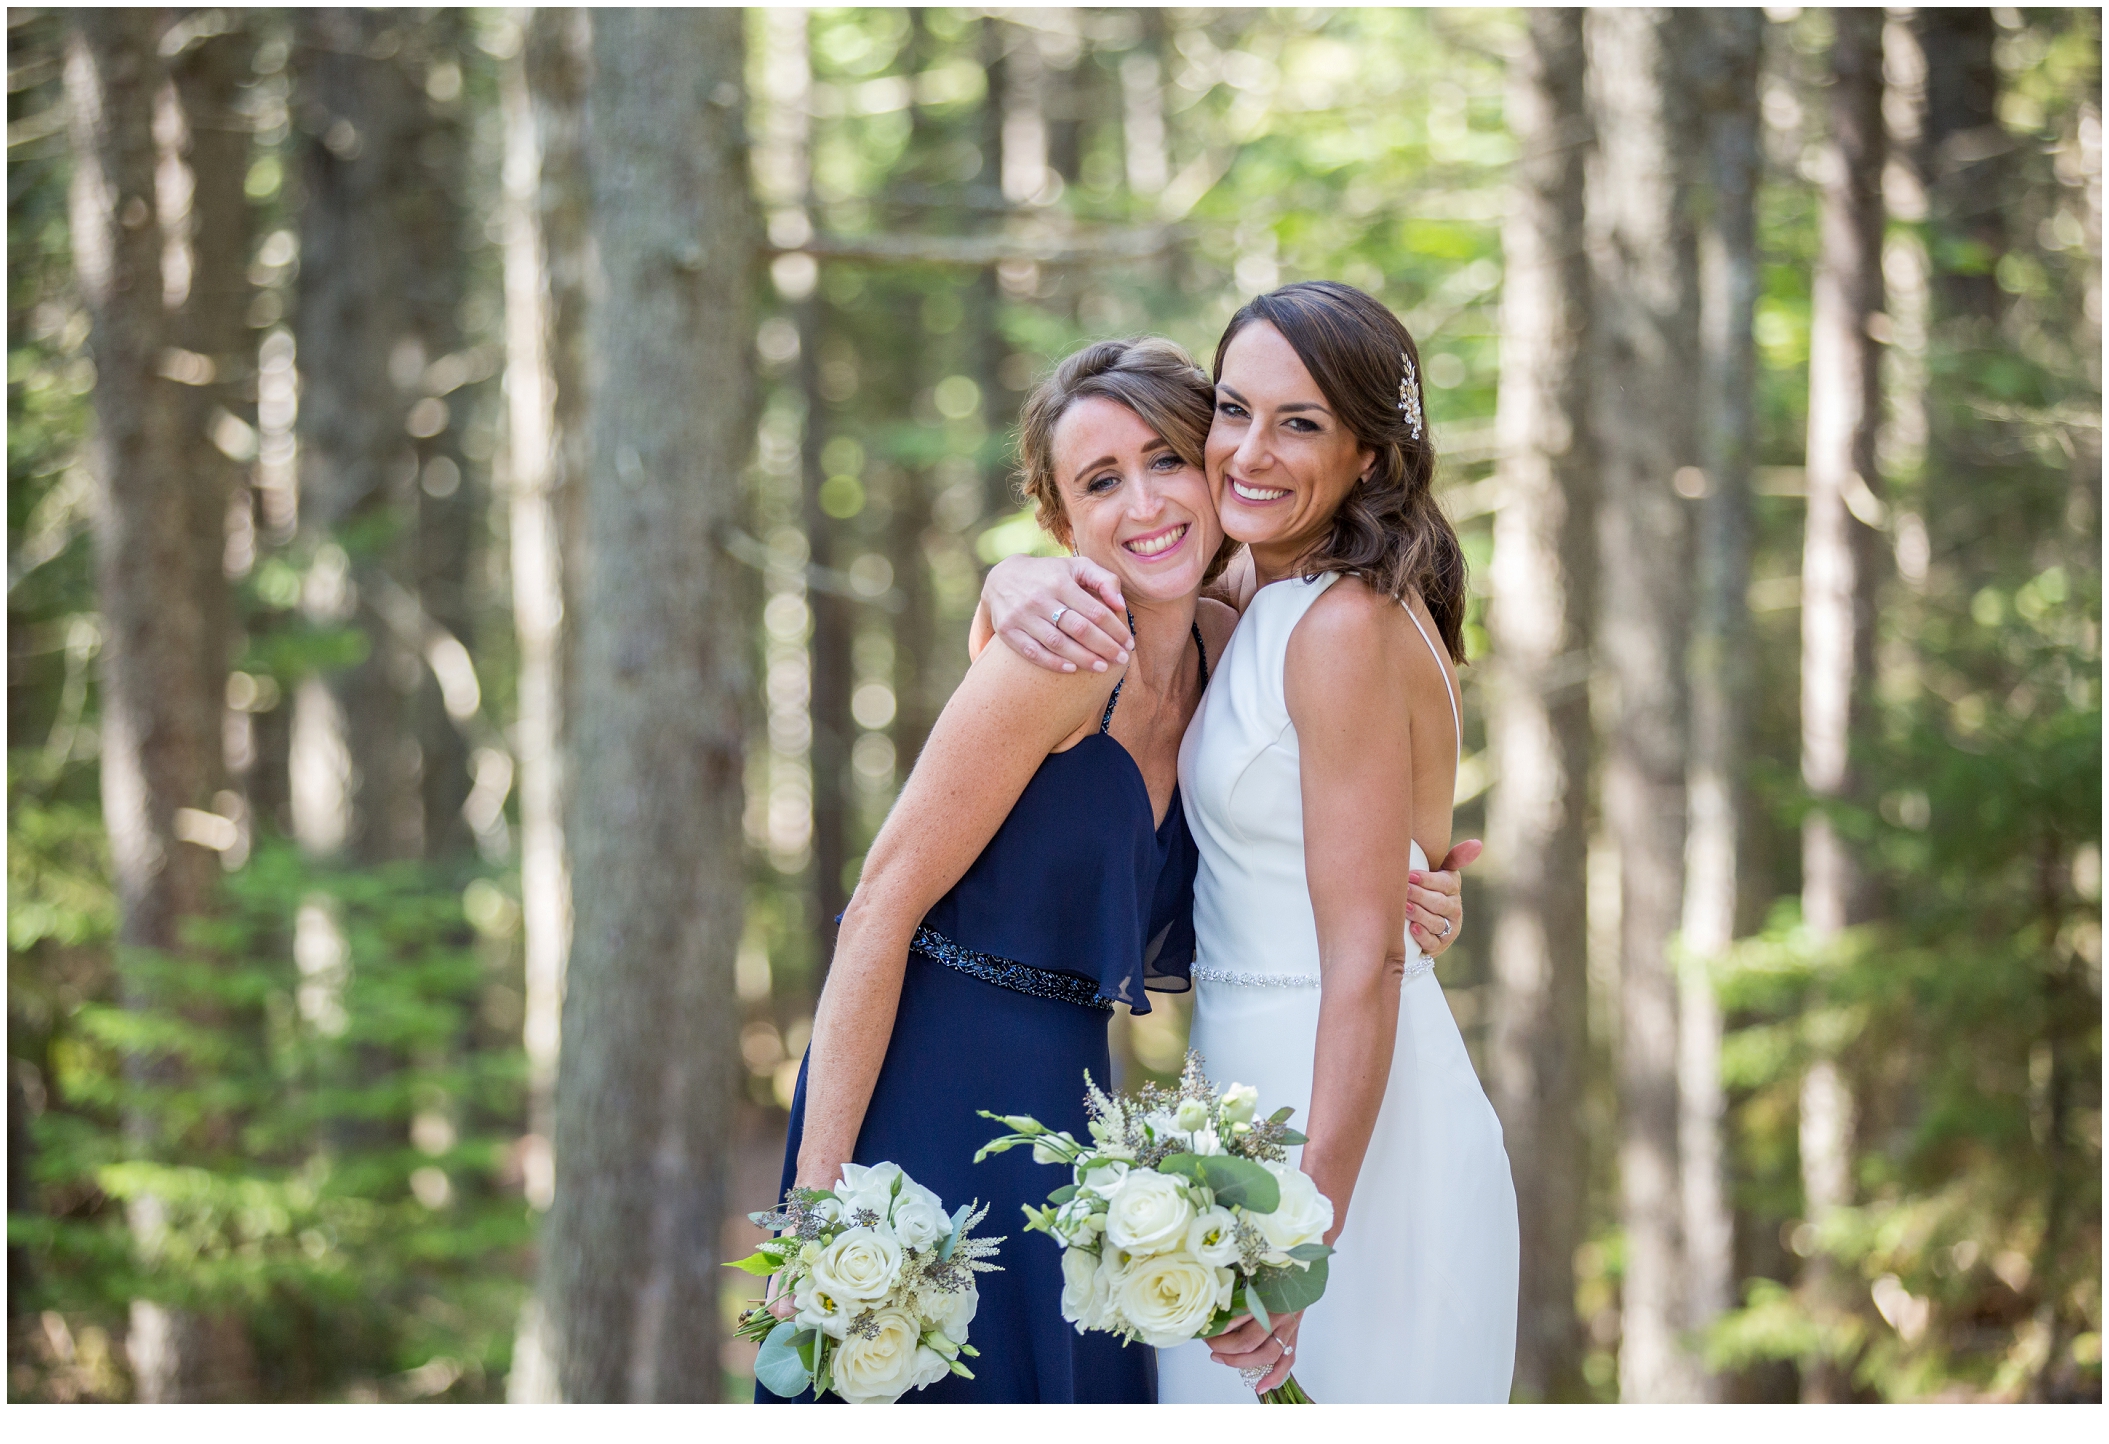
[1677, 6, 1765, 1400]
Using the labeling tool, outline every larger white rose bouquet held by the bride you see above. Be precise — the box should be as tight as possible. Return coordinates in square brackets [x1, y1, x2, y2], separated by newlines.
[974, 1052, 1333, 1404]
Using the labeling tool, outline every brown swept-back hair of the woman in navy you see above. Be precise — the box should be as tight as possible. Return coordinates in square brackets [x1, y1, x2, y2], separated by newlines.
[1019, 335, 1238, 582]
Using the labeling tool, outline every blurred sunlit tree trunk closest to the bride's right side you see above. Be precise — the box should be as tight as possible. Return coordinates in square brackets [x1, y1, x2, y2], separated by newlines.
[1487, 8, 1597, 1400]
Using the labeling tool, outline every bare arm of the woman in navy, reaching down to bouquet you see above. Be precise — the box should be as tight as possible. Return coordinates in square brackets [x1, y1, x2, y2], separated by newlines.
[797, 647, 1111, 1189]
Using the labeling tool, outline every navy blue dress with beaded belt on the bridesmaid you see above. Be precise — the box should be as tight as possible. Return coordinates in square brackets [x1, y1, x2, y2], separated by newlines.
[755, 628, 1208, 1404]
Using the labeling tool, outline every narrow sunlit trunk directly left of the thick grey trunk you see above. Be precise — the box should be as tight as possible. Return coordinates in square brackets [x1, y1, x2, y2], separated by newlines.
[500, 6, 591, 1402]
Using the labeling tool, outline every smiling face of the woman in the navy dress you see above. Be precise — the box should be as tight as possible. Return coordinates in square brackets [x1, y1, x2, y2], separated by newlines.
[1052, 396, 1223, 601]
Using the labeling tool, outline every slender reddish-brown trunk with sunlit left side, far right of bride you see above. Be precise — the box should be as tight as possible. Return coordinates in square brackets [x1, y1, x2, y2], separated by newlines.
[1801, 8, 1885, 1400]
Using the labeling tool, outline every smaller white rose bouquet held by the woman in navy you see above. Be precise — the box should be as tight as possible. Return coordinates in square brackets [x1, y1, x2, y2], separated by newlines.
[725, 1164, 1004, 1404]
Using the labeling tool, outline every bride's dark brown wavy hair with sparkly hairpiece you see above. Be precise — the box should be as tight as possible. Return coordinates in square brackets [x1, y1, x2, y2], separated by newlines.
[1215, 280, 1466, 662]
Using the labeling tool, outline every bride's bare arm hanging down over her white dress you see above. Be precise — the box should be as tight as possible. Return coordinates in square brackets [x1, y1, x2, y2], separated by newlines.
[1282, 582, 1413, 1242]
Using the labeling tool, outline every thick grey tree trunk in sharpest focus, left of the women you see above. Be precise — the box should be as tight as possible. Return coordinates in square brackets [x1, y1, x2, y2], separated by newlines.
[542, 8, 757, 1400]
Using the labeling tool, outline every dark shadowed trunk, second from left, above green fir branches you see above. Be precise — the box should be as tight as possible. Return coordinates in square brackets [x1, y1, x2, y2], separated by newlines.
[293, 8, 458, 862]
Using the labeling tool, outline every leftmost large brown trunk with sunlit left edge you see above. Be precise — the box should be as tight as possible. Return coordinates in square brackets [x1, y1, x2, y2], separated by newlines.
[65, 8, 247, 1402]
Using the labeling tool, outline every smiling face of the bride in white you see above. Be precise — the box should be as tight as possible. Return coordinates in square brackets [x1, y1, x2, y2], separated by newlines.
[1208, 320, 1375, 565]
